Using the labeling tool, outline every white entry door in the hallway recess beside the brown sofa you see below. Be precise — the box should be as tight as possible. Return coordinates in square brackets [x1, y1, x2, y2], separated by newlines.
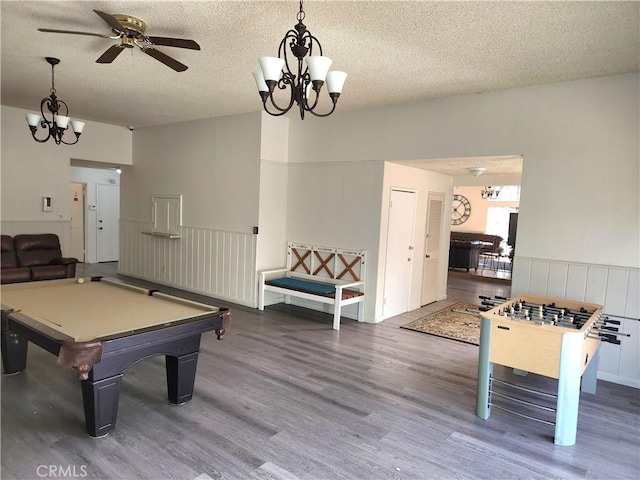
[96, 184, 120, 262]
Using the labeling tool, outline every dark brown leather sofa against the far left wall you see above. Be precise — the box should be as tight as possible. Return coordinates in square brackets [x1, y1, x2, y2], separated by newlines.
[0, 233, 78, 283]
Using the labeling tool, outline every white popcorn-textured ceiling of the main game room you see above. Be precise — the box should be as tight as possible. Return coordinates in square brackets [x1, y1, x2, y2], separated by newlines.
[0, 0, 640, 176]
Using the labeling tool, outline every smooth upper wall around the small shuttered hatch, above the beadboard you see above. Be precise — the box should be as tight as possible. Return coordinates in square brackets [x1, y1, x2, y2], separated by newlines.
[120, 113, 261, 233]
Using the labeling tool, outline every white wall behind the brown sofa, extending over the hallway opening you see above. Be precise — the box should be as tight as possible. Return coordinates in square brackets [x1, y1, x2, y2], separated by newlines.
[0, 105, 132, 254]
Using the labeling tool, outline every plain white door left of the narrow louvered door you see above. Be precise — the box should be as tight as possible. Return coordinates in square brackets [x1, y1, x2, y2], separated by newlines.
[382, 190, 416, 318]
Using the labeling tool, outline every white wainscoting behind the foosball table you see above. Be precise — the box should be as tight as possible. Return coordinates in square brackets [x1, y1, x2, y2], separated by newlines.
[511, 257, 640, 388]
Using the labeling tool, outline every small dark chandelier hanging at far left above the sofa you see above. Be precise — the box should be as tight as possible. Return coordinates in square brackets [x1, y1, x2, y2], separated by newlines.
[26, 57, 84, 145]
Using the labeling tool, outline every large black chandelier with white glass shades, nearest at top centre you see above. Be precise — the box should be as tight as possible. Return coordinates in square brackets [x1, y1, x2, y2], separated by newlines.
[253, 0, 347, 120]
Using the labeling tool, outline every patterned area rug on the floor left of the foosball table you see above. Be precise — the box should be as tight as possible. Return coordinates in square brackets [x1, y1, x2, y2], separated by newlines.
[400, 302, 480, 345]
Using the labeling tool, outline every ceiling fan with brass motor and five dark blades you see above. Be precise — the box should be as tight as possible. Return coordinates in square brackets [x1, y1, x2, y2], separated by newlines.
[38, 10, 200, 72]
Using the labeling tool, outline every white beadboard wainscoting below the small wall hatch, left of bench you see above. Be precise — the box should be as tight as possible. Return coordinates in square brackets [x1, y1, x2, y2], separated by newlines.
[118, 220, 257, 308]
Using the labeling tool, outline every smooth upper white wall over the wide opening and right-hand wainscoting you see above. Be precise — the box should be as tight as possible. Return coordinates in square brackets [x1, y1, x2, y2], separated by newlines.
[289, 74, 640, 272]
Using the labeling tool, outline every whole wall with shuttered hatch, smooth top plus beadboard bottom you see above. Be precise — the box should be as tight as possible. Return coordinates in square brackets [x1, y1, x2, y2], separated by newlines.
[118, 113, 262, 306]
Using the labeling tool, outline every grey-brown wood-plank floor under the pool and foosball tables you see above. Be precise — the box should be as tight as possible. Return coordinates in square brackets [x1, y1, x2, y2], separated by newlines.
[0, 264, 640, 480]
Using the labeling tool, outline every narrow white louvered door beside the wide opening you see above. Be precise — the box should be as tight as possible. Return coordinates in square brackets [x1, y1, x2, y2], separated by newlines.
[420, 192, 444, 305]
